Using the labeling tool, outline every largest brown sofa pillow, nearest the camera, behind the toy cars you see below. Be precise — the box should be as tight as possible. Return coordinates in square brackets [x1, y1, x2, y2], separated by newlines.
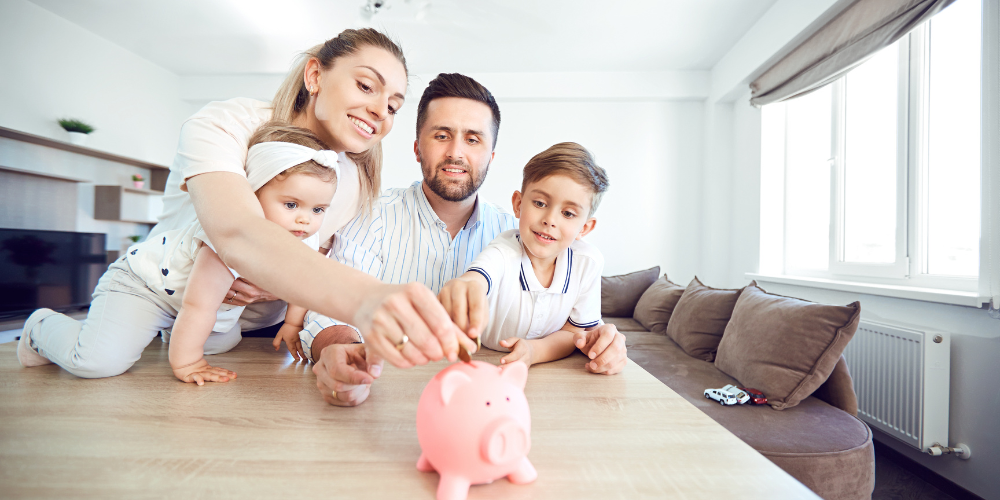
[715, 284, 861, 410]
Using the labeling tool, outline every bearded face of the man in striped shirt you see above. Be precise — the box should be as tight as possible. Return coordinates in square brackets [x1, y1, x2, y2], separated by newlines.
[413, 97, 493, 201]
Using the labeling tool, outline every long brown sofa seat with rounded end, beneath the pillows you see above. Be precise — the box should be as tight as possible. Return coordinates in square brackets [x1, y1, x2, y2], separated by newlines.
[625, 332, 875, 500]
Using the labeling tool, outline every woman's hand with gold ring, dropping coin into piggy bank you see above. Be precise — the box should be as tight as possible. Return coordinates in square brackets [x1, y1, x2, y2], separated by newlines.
[354, 283, 476, 368]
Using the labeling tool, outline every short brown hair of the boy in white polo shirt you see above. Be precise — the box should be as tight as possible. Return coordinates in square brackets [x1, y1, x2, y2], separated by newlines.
[521, 142, 610, 217]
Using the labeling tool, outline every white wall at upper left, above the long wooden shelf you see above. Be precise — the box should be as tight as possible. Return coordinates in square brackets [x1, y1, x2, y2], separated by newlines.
[0, 0, 189, 165]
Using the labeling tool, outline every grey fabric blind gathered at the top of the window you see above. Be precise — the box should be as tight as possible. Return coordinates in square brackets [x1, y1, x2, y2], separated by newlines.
[750, 0, 955, 106]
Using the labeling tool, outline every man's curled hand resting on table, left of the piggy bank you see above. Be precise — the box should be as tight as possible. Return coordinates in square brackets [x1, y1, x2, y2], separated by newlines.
[313, 344, 383, 406]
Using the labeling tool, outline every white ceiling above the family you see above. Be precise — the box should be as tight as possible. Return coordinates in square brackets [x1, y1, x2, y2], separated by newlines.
[32, 0, 776, 76]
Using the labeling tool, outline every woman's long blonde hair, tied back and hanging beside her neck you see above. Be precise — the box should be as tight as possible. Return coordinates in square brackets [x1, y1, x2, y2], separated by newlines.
[271, 28, 409, 211]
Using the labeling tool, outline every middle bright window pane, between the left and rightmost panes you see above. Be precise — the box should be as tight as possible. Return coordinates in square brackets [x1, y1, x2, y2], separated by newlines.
[843, 43, 899, 263]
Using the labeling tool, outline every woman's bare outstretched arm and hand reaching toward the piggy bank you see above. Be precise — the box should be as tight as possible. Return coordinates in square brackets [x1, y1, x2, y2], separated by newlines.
[187, 172, 464, 360]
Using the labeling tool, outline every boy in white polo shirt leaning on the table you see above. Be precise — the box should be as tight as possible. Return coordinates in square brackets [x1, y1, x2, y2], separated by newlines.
[439, 142, 608, 372]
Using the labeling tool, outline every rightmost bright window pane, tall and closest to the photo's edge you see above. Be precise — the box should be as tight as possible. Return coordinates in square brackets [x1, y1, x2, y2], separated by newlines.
[924, 0, 982, 276]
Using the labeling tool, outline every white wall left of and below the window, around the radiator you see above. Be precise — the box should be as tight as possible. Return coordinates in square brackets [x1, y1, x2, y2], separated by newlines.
[698, 0, 1000, 498]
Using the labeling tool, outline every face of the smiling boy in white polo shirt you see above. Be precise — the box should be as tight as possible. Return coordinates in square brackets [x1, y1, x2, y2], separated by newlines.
[511, 174, 597, 263]
